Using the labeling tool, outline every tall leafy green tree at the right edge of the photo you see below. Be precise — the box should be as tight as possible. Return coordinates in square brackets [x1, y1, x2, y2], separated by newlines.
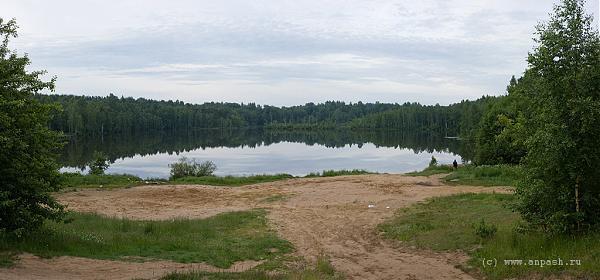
[516, 0, 600, 232]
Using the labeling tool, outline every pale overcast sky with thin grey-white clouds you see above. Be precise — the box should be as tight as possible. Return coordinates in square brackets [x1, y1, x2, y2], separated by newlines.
[0, 0, 600, 106]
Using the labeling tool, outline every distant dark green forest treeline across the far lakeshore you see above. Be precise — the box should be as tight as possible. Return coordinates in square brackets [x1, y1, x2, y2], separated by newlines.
[36, 94, 499, 138]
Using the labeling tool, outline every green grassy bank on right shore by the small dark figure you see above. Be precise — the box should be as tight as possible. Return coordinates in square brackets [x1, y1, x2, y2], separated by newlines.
[406, 165, 521, 186]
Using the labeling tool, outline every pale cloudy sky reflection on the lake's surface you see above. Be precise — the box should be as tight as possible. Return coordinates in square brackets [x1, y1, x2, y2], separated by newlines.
[96, 142, 461, 178]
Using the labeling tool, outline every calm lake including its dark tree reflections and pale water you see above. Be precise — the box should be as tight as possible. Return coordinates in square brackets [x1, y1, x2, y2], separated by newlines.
[60, 129, 472, 178]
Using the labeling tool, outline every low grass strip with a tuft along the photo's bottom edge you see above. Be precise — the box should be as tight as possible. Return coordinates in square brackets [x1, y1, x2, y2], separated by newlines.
[162, 257, 343, 280]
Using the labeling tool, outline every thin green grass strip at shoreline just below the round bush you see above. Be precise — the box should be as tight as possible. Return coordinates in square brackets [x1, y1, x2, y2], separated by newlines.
[169, 174, 294, 186]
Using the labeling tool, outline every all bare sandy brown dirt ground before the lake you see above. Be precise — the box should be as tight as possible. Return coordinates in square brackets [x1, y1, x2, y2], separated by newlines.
[0, 175, 510, 279]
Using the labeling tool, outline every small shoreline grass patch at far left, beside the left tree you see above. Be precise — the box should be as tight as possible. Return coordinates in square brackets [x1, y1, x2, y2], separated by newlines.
[61, 173, 146, 189]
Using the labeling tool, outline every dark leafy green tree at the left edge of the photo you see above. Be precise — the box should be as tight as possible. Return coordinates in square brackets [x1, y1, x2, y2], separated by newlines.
[0, 18, 63, 236]
